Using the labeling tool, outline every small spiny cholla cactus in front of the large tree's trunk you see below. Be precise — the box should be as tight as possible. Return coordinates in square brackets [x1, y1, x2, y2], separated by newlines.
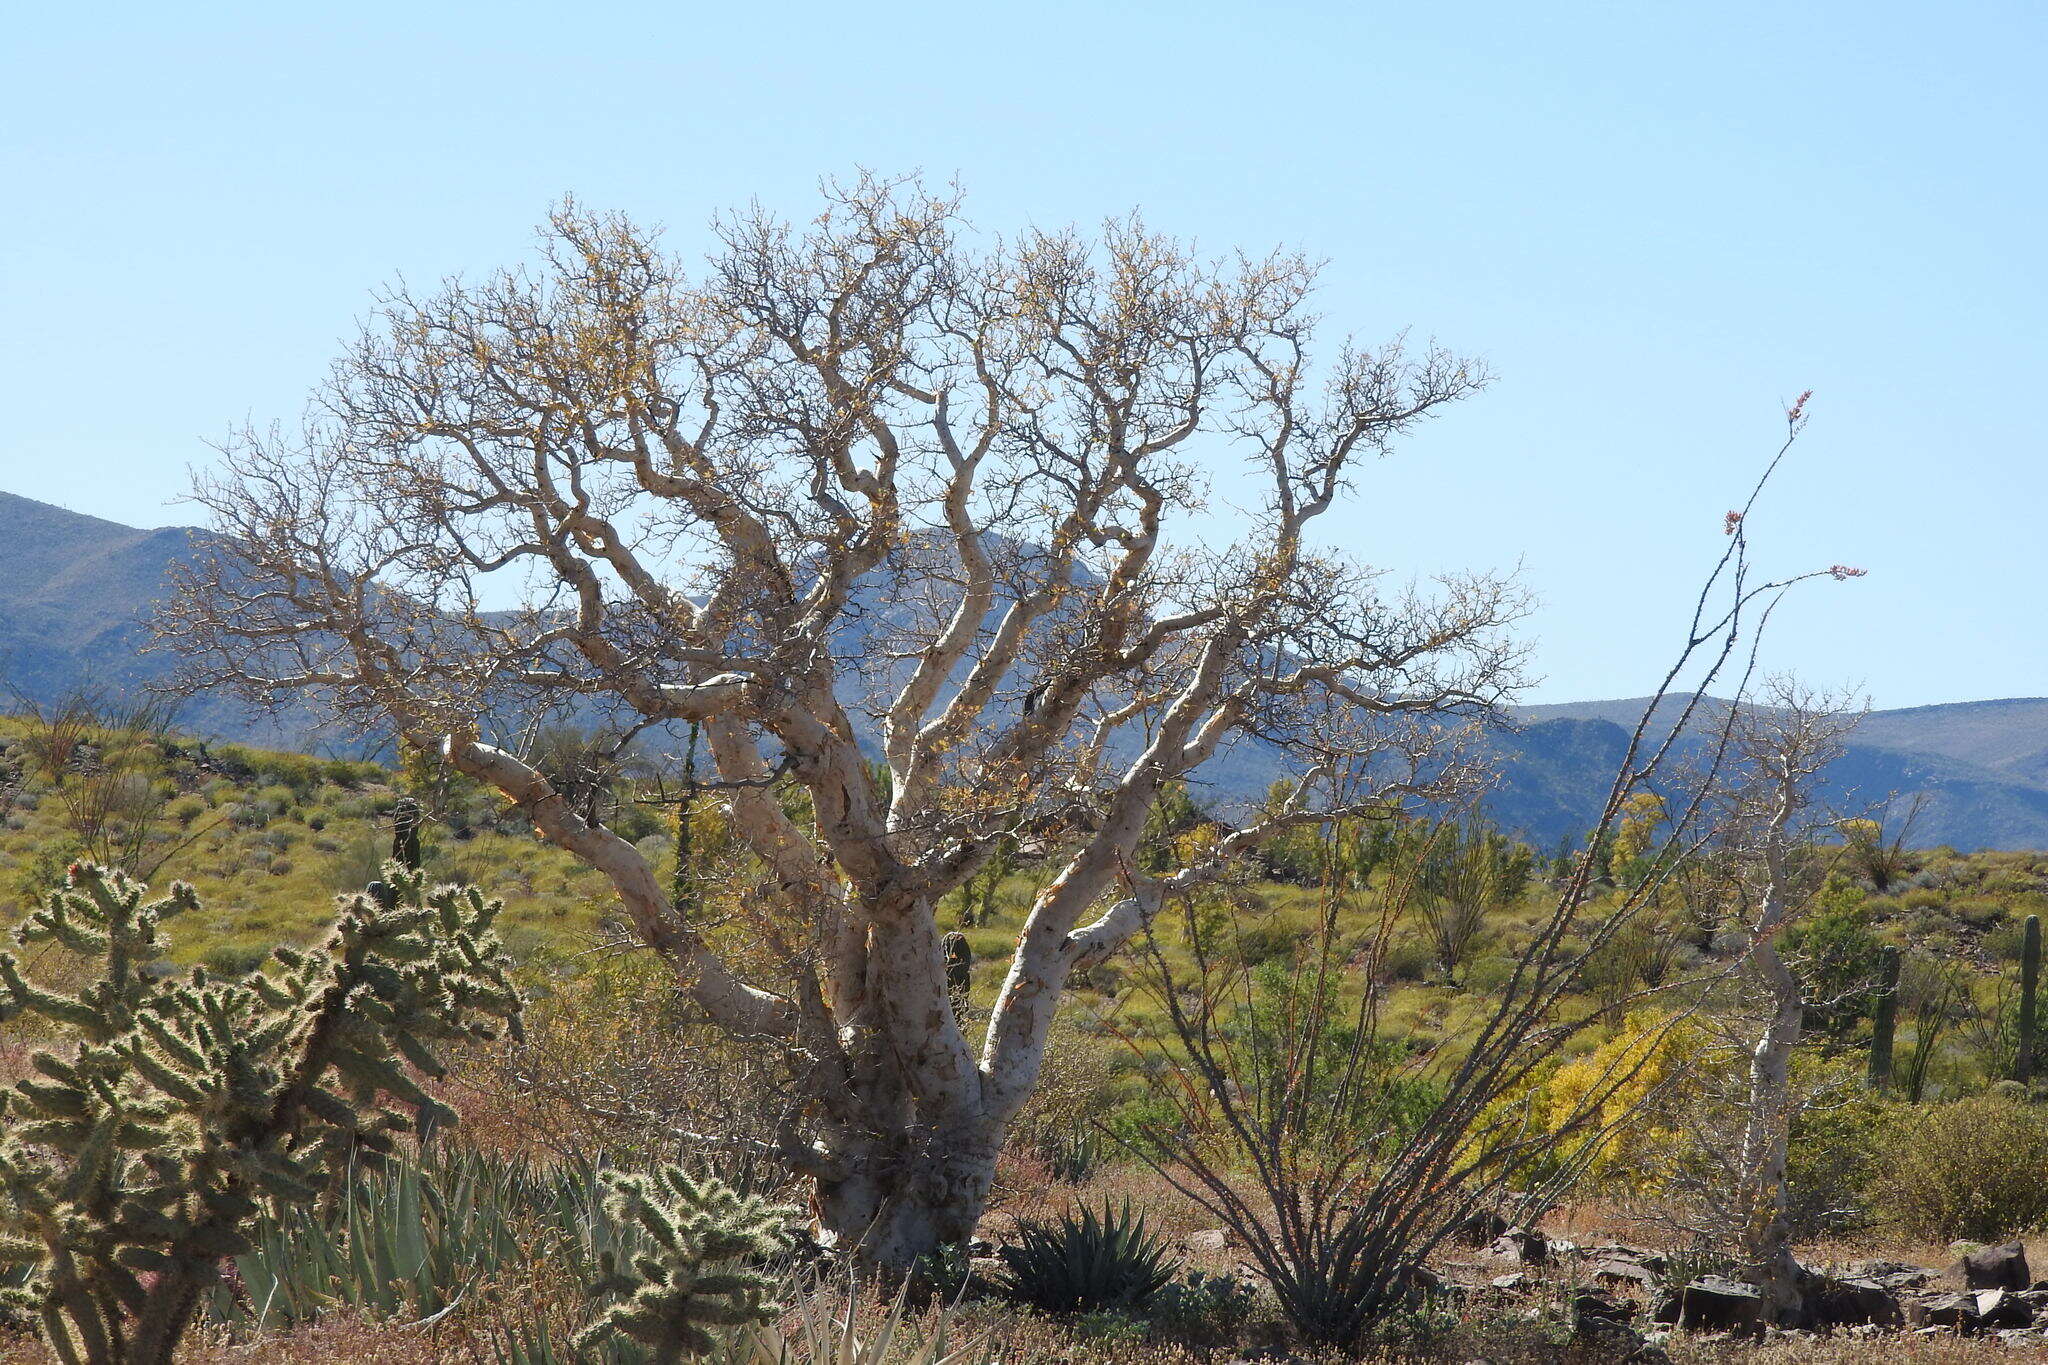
[575, 1166, 788, 1365]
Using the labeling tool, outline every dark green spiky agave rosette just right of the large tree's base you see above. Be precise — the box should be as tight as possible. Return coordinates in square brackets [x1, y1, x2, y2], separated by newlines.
[999, 1199, 1180, 1314]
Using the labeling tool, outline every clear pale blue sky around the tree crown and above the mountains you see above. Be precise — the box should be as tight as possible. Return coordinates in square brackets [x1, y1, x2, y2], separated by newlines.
[0, 0, 2048, 706]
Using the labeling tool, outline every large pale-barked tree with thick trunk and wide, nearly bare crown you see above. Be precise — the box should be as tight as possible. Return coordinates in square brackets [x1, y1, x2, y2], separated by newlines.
[164, 178, 1520, 1263]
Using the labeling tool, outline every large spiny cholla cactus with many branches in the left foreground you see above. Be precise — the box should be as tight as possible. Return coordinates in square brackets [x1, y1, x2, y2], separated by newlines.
[0, 864, 520, 1365]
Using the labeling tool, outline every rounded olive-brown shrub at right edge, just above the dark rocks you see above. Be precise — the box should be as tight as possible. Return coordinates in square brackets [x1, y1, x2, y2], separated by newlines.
[1878, 1095, 2048, 1242]
